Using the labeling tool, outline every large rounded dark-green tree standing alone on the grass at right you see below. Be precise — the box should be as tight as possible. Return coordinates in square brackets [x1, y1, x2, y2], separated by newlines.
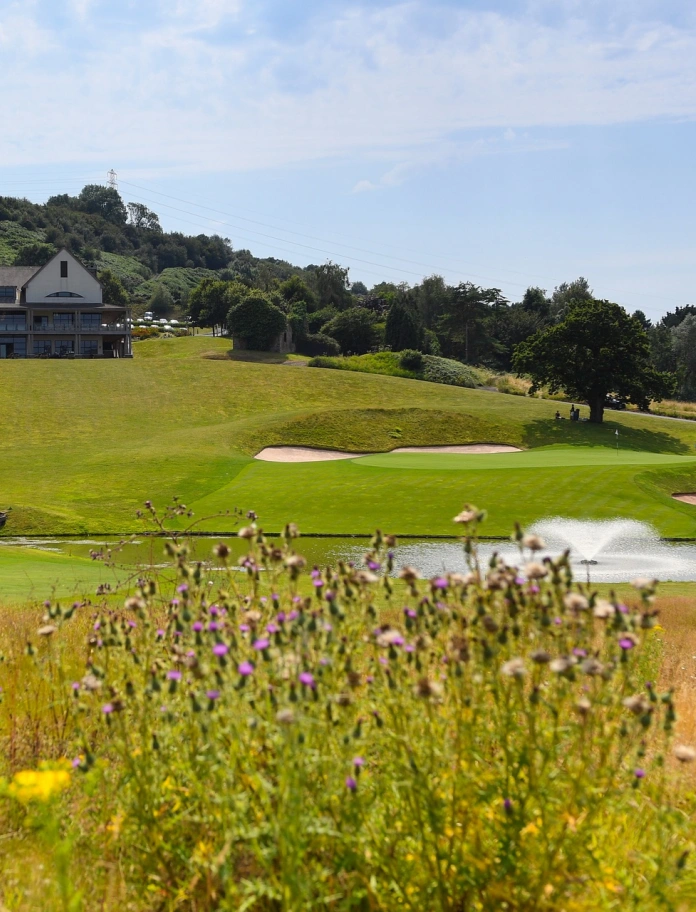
[513, 299, 674, 423]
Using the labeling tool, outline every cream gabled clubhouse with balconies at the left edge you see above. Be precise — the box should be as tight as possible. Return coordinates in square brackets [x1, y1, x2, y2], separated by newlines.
[0, 250, 133, 359]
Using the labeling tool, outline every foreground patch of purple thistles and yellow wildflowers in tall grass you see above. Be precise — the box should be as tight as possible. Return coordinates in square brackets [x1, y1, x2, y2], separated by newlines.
[0, 507, 696, 912]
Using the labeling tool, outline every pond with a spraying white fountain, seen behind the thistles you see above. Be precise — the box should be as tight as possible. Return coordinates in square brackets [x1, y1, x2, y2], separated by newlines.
[0, 517, 696, 582]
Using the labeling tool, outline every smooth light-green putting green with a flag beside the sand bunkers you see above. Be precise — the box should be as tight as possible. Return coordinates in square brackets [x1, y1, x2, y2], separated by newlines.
[353, 446, 696, 472]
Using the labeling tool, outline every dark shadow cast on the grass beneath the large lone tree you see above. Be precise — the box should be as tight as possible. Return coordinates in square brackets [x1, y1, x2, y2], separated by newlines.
[522, 418, 696, 456]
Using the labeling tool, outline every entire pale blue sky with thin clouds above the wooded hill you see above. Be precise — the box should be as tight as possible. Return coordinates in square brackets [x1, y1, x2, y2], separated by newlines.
[0, 0, 696, 317]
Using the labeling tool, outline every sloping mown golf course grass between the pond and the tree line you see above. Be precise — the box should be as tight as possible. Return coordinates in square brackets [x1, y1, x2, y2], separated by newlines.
[0, 336, 696, 537]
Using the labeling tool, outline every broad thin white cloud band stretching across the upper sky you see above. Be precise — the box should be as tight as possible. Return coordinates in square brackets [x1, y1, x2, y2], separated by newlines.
[0, 0, 696, 173]
